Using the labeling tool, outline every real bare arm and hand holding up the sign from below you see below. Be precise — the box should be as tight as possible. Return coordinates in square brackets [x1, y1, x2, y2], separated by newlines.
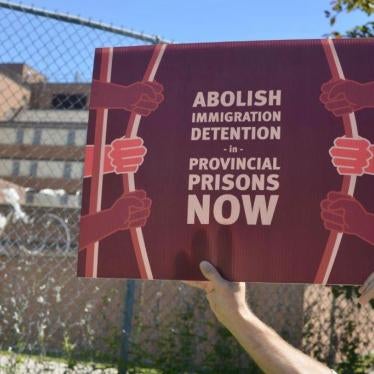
[188, 261, 331, 374]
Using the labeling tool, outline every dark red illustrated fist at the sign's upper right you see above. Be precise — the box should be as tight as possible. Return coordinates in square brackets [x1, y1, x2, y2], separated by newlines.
[320, 79, 374, 117]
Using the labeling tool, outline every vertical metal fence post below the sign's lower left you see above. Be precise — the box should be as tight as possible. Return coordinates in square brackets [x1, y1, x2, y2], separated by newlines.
[118, 279, 136, 374]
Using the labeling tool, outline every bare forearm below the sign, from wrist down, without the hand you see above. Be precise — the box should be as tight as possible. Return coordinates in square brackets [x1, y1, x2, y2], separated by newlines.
[226, 311, 331, 374]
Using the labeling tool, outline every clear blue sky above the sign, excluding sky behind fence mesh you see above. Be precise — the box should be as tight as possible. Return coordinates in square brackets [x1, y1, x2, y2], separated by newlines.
[7, 0, 368, 42]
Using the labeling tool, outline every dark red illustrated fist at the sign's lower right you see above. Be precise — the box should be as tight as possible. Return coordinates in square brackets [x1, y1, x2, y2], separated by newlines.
[321, 191, 374, 245]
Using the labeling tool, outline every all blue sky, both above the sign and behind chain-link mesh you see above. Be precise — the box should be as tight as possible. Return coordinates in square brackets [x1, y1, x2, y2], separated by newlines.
[0, 0, 369, 82]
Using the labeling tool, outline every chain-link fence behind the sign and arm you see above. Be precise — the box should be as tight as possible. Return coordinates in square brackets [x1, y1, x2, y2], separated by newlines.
[0, 1, 374, 373]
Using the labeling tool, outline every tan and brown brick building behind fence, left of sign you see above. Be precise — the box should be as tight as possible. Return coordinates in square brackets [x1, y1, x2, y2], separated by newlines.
[0, 64, 90, 207]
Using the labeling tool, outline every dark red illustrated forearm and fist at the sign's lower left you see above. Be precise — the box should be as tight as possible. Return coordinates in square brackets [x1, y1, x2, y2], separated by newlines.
[79, 190, 152, 248]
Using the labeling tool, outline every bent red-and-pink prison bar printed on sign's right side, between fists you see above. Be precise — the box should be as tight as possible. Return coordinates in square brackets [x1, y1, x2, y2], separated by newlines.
[314, 39, 359, 284]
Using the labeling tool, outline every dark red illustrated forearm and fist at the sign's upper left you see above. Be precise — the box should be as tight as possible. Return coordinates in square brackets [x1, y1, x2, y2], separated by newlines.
[90, 79, 164, 116]
